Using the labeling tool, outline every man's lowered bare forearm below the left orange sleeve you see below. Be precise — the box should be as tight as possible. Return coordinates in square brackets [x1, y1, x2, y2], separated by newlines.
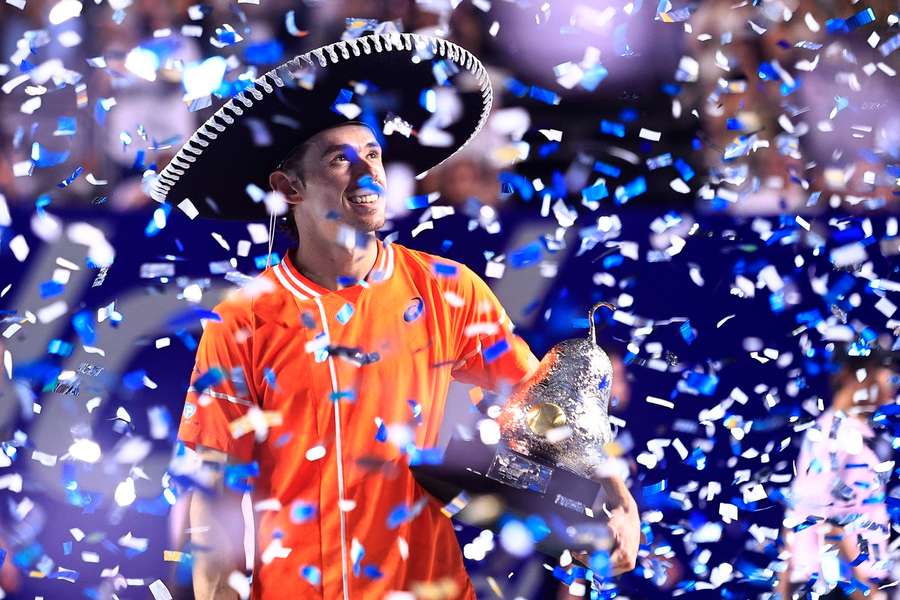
[190, 492, 246, 600]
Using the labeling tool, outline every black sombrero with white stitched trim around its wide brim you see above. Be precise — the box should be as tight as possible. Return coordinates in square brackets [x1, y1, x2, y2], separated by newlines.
[151, 33, 493, 221]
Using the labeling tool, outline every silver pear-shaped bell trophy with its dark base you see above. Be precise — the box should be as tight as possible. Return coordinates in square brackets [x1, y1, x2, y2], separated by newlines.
[412, 302, 615, 556]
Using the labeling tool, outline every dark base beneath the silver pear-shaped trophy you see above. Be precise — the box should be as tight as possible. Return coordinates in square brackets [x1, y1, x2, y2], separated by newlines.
[411, 435, 612, 559]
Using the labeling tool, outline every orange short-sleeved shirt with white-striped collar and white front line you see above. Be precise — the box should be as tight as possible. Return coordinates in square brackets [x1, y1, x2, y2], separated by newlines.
[178, 242, 538, 600]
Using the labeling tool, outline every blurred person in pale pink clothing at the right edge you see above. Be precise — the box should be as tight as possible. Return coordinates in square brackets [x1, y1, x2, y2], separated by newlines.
[777, 344, 896, 600]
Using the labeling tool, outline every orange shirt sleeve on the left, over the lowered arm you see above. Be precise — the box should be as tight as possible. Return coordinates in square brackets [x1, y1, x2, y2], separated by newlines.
[178, 303, 258, 462]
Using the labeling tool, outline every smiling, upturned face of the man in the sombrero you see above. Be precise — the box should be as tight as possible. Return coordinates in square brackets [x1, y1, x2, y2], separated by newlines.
[297, 125, 385, 236]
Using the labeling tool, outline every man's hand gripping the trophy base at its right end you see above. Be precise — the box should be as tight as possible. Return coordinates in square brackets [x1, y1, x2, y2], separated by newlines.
[572, 476, 641, 575]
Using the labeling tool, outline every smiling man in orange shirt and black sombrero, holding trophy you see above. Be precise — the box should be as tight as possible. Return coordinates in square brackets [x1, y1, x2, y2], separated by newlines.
[157, 34, 639, 599]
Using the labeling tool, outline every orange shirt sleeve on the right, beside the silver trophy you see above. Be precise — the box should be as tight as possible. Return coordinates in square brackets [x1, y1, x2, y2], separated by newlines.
[452, 265, 539, 390]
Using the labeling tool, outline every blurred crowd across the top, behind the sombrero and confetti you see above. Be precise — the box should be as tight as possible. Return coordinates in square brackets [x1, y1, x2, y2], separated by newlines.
[0, 0, 900, 223]
